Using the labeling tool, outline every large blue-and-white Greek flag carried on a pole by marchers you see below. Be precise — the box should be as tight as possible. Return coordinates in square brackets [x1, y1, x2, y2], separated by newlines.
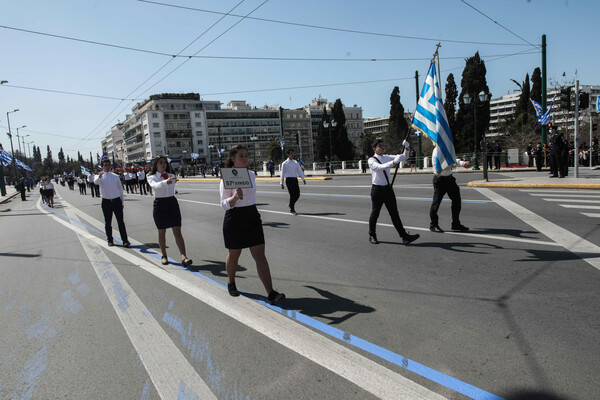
[412, 62, 456, 176]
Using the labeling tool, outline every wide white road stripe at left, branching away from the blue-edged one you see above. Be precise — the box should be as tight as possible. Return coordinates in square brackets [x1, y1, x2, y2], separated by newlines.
[37, 200, 216, 399]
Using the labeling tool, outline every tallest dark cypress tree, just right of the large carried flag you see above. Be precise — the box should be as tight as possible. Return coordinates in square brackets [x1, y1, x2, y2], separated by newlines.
[452, 52, 491, 153]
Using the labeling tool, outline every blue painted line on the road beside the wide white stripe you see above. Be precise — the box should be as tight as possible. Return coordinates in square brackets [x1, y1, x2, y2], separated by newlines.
[48, 202, 504, 400]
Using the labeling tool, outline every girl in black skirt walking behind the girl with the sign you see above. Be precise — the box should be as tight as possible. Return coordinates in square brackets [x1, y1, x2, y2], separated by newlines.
[147, 156, 192, 267]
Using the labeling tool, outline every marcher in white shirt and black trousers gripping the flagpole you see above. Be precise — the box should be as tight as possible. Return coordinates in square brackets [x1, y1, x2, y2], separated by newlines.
[369, 139, 420, 244]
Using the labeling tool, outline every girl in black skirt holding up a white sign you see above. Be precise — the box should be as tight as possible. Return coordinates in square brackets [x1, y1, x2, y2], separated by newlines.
[219, 145, 285, 304]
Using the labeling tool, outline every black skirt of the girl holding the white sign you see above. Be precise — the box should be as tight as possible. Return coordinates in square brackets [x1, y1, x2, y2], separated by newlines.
[223, 205, 265, 249]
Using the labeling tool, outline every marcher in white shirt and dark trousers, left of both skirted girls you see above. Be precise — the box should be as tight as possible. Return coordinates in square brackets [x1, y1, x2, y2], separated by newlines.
[94, 156, 131, 247]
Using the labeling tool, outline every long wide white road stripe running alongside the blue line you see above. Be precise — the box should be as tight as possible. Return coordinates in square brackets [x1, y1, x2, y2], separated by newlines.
[43, 199, 444, 400]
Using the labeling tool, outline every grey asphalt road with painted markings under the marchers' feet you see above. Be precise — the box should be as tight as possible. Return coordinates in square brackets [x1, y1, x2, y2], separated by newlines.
[0, 174, 600, 400]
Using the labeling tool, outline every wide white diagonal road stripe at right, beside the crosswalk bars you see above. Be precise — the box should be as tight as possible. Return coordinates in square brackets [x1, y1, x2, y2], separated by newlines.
[477, 188, 600, 270]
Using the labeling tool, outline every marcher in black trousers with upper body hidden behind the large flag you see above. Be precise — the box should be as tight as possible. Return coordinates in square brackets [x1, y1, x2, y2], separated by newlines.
[429, 146, 471, 233]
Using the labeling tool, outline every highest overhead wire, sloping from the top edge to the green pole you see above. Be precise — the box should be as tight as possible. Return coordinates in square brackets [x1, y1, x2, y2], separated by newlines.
[137, 0, 536, 46]
